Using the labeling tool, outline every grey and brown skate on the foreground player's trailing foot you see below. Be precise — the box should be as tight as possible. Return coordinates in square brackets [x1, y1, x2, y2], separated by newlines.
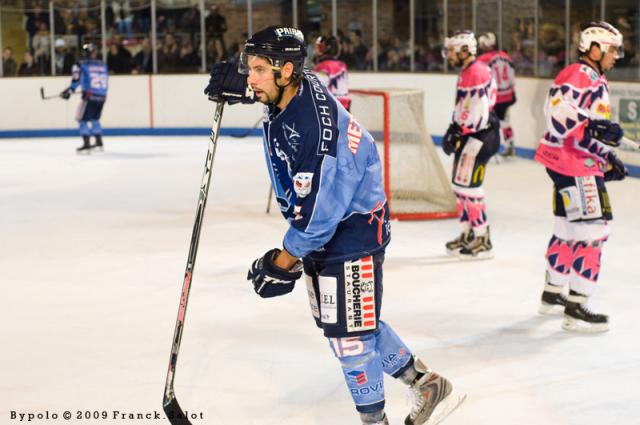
[404, 360, 467, 425]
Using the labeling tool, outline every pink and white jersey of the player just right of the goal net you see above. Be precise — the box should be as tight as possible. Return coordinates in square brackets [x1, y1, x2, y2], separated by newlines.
[453, 60, 497, 134]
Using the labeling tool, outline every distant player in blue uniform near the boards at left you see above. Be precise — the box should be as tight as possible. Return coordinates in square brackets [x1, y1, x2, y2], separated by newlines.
[60, 43, 109, 153]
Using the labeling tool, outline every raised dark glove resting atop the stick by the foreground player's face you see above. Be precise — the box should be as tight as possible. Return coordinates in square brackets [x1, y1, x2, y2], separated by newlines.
[204, 62, 257, 105]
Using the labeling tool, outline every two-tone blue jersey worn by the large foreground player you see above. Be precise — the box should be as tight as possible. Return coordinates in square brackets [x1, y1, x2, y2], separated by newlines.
[263, 73, 390, 261]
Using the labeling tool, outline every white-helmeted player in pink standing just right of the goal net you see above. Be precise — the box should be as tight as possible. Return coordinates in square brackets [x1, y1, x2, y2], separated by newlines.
[442, 31, 500, 259]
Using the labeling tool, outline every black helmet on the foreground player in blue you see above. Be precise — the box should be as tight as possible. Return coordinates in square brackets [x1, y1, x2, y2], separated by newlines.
[240, 26, 307, 80]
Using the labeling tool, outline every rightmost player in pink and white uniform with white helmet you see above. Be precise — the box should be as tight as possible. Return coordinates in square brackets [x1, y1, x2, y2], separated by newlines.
[535, 22, 628, 332]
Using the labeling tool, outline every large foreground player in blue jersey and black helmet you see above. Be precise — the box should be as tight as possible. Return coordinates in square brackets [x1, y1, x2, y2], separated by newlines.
[205, 27, 462, 424]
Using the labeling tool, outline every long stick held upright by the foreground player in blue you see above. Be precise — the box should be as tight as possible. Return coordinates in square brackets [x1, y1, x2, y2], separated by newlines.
[162, 102, 224, 425]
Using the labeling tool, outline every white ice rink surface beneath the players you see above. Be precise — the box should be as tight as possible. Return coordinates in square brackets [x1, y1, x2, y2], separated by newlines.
[0, 137, 640, 425]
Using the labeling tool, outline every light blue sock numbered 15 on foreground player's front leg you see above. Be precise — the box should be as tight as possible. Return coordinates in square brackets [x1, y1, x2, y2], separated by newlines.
[329, 334, 384, 413]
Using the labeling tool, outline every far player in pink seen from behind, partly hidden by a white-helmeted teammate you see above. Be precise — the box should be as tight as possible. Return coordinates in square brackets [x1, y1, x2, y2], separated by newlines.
[478, 32, 516, 156]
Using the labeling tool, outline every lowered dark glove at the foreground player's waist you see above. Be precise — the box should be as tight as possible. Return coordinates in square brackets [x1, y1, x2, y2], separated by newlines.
[247, 248, 302, 298]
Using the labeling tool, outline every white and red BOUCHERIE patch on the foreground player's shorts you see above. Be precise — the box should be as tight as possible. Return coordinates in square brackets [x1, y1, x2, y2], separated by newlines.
[344, 256, 376, 332]
